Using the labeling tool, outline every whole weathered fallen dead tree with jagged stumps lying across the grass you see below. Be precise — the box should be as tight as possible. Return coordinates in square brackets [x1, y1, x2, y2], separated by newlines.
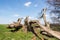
[8, 9, 60, 40]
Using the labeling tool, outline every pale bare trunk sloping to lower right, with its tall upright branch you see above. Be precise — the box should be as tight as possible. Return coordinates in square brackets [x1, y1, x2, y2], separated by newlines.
[37, 9, 60, 39]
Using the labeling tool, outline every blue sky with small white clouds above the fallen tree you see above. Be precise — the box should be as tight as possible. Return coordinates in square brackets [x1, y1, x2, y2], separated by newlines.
[0, 0, 50, 24]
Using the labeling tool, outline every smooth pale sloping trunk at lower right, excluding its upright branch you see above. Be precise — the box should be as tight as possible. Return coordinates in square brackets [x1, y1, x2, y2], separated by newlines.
[38, 23, 60, 39]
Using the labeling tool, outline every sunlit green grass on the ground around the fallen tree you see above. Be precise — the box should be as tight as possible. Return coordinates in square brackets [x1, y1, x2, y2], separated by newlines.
[0, 24, 58, 40]
